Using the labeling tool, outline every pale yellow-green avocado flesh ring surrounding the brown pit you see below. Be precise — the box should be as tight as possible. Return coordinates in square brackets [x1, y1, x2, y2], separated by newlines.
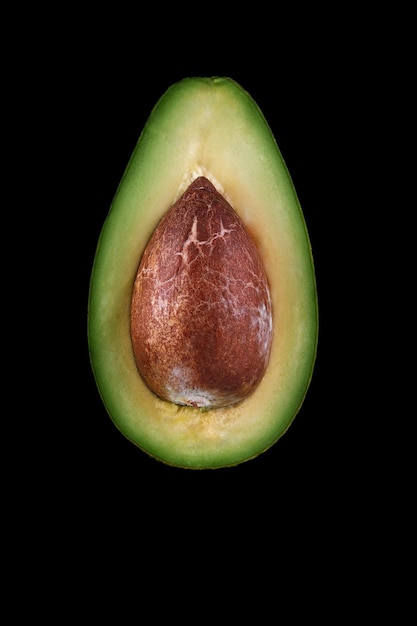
[88, 77, 318, 469]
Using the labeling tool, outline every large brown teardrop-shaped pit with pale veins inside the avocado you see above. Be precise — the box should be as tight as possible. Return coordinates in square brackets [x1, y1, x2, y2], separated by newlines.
[131, 176, 272, 408]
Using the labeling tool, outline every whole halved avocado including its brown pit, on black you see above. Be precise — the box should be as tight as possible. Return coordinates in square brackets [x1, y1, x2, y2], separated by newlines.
[88, 77, 318, 469]
